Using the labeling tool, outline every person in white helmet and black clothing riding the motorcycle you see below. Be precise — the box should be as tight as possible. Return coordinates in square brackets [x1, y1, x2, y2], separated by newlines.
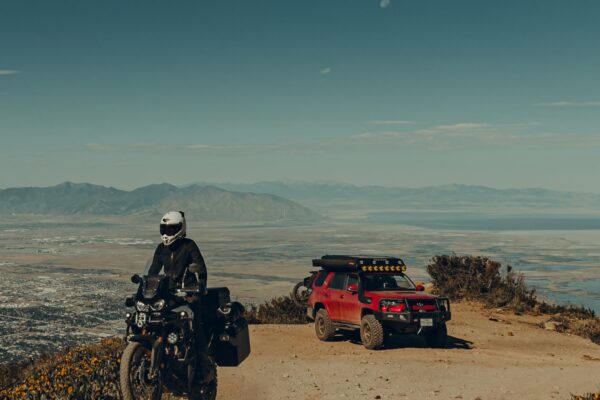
[148, 211, 212, 383]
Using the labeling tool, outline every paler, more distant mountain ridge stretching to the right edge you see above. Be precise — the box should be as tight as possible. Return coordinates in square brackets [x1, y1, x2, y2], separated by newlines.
[196, 181, 600, 213]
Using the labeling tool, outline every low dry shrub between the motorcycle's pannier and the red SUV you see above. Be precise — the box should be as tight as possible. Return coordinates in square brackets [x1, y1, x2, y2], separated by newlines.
[244, 295, 308, 324]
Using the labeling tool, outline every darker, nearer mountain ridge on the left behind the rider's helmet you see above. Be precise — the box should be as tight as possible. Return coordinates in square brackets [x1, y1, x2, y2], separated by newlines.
[0, 182, 320, 222]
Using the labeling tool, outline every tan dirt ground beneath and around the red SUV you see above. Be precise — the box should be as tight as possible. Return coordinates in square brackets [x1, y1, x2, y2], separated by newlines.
[219, 303, 600, 400]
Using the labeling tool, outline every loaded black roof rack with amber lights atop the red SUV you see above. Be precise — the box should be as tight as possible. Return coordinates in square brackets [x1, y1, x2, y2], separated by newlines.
[313, 255, 406, 272]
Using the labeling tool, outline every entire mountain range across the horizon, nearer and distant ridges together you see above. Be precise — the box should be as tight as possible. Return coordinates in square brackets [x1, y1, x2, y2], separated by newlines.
[0, 182, 600, 222]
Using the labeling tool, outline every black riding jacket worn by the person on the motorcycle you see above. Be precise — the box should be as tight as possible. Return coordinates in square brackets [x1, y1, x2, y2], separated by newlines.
[148, 238, 207, 286]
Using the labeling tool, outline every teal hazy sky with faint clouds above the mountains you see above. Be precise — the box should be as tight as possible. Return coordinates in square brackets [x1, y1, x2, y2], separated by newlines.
[0, 0, 600, 192]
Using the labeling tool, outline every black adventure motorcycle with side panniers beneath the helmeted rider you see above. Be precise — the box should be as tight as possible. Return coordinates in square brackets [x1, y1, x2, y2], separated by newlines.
[120, 264, 250, 400]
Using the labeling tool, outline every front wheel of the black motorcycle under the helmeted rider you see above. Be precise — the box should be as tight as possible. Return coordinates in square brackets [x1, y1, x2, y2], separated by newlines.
[119, 342, 162, 400]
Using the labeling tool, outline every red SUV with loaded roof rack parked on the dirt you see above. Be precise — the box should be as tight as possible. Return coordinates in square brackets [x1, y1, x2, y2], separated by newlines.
[307, 256, 451, 349]
